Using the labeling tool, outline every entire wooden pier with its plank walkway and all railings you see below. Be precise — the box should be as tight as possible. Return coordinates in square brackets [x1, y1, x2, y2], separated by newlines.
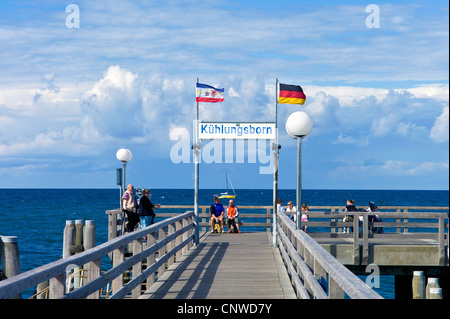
[0, 206, 449, 299]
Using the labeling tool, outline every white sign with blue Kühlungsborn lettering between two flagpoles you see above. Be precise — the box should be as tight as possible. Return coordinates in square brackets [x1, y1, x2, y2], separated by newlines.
[198, 122, 276, 140]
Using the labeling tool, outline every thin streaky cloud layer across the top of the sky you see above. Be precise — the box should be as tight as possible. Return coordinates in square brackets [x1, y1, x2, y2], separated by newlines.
[0, 0, 448, 86]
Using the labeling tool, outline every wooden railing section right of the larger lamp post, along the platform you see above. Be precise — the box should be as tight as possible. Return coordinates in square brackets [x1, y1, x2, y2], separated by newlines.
[302, 206, 449, 266]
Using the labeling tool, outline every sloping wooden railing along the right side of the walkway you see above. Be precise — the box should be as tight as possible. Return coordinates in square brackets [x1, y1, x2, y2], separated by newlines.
[277, 214, 382, 299]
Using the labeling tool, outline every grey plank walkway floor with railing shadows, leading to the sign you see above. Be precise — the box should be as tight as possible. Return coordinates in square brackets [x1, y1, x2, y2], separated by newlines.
[140, 232, 296, 299]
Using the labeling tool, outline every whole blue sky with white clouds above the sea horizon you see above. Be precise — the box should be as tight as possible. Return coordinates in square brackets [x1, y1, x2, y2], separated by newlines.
[0, 0, 449, 190]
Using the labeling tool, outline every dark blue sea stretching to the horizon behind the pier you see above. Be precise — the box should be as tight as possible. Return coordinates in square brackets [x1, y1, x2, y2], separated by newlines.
[0, 188, 449, 299]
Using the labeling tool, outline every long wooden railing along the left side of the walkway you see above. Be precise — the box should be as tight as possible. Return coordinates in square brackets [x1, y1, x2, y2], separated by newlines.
[0, 212, 194, 299]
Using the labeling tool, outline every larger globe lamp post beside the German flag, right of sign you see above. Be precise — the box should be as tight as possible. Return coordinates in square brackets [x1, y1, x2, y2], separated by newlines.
[286, 111, 313, 229]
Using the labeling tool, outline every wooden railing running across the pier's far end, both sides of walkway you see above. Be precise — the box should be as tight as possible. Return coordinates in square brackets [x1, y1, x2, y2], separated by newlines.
[107, 205, 449, 266]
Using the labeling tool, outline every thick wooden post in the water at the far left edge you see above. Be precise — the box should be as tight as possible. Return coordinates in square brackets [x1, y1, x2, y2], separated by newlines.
[0, 236, 21, 299]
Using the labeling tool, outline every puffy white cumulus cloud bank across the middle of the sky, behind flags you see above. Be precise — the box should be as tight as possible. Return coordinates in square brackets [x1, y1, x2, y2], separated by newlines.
[0, 61, 448, 190]
